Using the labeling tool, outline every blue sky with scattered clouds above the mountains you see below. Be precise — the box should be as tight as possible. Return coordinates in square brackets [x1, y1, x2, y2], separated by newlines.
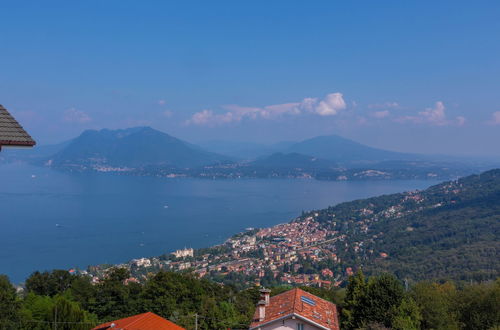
[0, 0, 500, 156]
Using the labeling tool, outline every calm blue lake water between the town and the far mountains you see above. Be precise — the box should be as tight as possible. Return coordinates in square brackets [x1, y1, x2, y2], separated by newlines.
[0, 164, 436, 282]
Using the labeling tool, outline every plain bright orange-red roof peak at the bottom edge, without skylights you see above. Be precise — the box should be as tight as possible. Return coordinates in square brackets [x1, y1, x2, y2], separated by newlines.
[92, 312, 185, 330]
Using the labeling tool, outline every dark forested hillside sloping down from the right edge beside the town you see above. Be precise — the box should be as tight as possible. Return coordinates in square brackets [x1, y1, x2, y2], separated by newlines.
[308, 170, 500, 280]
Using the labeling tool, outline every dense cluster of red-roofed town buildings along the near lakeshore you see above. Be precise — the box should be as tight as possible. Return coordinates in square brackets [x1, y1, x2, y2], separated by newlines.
[79, 217, 353, 287]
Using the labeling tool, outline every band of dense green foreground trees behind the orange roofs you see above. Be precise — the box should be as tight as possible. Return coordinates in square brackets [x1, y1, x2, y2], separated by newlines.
[0, 268, 500, 330]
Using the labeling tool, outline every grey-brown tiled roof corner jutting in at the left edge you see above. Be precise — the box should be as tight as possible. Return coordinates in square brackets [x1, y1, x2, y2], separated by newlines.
[0, 105, 35, 147]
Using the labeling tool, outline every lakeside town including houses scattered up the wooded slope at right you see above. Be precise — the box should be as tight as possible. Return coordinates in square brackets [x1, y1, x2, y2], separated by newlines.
[70, 181, 462, 288]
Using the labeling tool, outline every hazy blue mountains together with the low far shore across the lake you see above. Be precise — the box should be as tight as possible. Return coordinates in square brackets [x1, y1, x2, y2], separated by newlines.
[0, 127, 494, 180]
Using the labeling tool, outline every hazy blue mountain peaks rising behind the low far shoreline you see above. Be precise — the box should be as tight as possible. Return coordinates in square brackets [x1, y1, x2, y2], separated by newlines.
[42, 127, 442, 167]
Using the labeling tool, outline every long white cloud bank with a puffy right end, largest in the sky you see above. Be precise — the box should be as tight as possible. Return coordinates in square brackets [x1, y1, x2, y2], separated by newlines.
[186, 93, 346, 126]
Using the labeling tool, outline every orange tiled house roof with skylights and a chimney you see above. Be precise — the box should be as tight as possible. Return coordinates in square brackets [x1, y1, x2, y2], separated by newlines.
[250, 288, 339, 330]
